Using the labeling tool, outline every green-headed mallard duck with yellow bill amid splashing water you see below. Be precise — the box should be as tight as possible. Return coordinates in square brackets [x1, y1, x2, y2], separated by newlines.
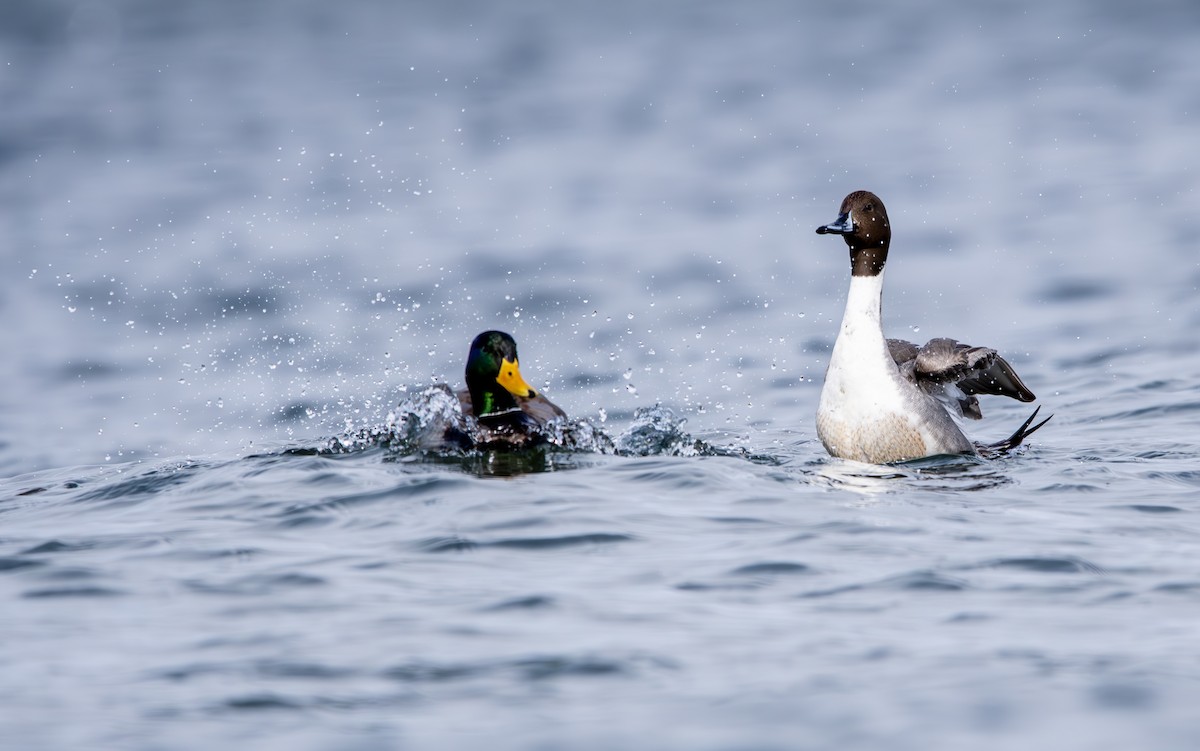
[458, 331, 566, 446]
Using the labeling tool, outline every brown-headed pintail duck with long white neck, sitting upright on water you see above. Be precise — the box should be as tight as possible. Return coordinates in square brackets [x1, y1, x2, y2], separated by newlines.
[817, 191, 1050, 464]
